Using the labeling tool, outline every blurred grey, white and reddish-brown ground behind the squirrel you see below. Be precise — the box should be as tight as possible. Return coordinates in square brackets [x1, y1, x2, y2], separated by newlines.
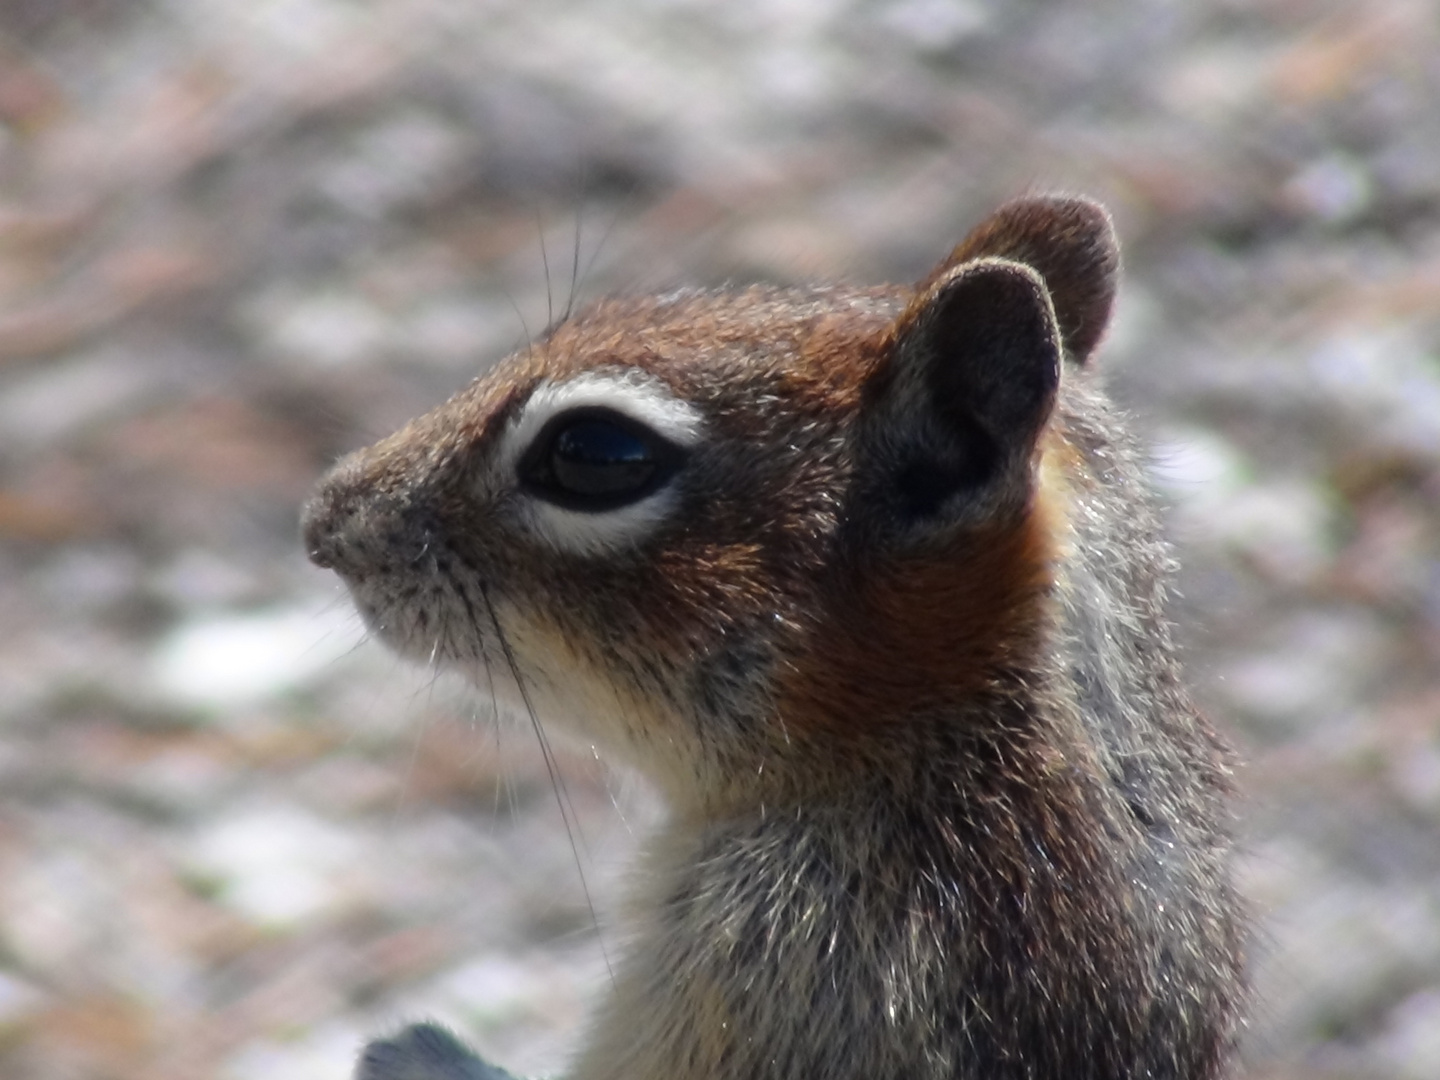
[0, 0, 1440, 1080]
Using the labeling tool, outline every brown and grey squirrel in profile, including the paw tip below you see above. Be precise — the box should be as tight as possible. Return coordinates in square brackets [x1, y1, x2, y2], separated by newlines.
[304, 196, 1246, 1080]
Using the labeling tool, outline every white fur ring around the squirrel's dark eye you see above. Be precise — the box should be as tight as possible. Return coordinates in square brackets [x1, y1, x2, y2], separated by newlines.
[495, 372, 704, 556]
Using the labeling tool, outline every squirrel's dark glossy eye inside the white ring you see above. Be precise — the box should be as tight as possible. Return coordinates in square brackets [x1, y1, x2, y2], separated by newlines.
[518, 409, 680, 513]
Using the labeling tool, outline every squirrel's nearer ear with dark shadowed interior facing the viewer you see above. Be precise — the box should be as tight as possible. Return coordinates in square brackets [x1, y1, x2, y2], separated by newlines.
[871, 259, 1061, 517]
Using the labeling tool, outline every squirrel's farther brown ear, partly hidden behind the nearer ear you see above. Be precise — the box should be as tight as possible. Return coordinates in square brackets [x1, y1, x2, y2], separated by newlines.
[919, 196, 1120, 364]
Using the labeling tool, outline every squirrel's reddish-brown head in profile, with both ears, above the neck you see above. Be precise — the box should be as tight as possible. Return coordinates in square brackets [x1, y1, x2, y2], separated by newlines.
[304, 199, 1117, 812]
